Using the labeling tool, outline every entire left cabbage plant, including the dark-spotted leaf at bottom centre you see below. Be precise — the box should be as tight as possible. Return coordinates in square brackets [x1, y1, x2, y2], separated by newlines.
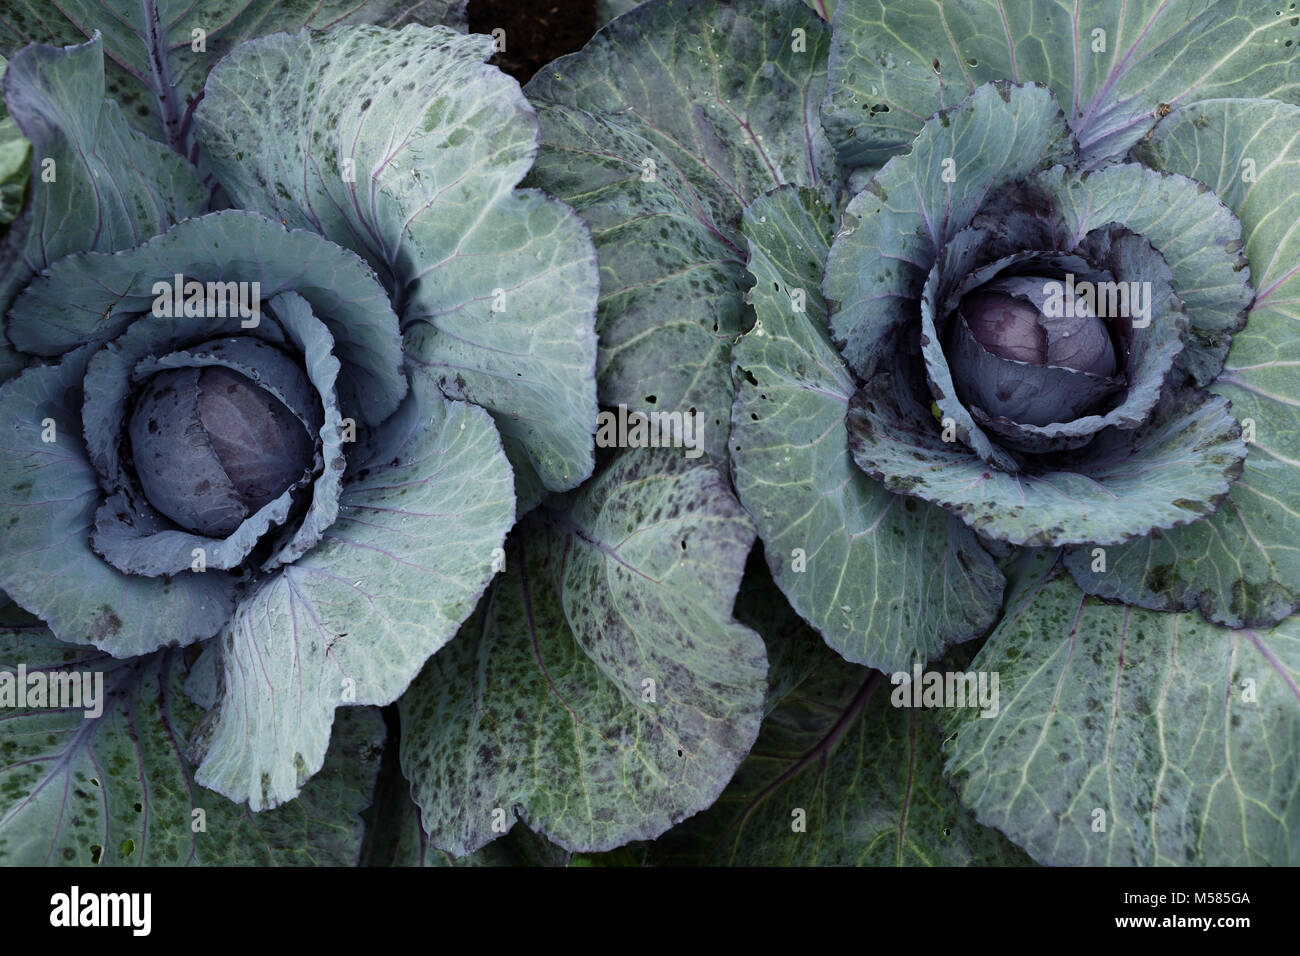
[0, 0, 767, 865]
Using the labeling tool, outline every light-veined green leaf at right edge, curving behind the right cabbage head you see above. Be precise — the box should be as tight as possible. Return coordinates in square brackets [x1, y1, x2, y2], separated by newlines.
[1066, 100, 1300, 627]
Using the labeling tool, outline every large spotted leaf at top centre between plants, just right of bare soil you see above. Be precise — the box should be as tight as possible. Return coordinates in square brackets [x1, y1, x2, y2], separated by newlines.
[528, 0, 833, 460]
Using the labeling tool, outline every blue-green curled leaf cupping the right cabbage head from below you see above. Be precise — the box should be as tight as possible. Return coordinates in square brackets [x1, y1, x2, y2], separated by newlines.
[849, 366, 1245, 546]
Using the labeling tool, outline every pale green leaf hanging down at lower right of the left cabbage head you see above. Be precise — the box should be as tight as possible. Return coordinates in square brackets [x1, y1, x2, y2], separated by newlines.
[192, 372, 515, 810]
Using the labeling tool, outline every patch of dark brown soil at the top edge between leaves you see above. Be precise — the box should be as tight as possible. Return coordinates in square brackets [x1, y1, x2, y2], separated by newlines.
[467, 0, 595, 83]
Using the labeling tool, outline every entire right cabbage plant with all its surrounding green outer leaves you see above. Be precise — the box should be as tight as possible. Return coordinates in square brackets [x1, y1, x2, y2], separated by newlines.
[527, 0, 1300, 864]
